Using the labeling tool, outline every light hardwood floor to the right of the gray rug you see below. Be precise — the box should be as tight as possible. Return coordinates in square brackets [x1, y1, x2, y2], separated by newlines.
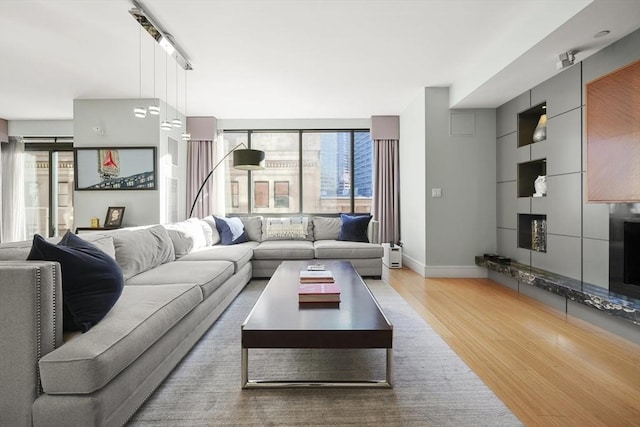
[389, 268, 640, 426]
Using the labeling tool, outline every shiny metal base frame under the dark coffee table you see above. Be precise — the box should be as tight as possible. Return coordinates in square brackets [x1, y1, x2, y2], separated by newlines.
[241, 348, 393, 389]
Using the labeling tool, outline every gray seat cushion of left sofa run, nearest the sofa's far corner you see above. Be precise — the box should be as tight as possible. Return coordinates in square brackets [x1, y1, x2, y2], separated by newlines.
[125, 261, 234, 298]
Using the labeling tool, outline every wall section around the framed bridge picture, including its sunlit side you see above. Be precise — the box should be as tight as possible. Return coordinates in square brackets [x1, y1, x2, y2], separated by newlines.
[73, 99, 187, 226]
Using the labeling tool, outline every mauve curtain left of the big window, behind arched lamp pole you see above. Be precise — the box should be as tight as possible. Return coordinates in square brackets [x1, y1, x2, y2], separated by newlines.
[187, 141, 216, 218]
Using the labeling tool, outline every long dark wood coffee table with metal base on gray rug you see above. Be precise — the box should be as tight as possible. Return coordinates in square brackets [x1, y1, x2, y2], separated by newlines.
[241, 261, 393, 388]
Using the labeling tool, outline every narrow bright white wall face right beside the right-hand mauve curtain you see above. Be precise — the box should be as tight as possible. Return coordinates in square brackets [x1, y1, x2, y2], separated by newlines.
[400, 89, 427, 276]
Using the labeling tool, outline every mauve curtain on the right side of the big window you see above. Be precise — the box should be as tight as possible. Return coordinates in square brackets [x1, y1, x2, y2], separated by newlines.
[373, 139, 400, 243]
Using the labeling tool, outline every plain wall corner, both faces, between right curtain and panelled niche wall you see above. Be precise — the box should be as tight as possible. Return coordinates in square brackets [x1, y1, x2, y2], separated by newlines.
[400, 87, 497, 277]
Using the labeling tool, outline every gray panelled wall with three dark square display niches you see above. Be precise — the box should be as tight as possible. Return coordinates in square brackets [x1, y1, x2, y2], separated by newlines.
[496, 30, 640, 289]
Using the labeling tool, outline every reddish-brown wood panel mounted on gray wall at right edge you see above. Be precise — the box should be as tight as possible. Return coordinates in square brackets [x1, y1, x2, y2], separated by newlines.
[586, 61, 640, 202]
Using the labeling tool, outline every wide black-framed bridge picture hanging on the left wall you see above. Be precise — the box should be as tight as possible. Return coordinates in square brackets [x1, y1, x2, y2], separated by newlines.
[74, 147, 156, 191]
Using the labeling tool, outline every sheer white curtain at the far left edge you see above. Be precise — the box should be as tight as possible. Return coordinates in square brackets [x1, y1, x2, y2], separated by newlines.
[0, 138, 27, 242]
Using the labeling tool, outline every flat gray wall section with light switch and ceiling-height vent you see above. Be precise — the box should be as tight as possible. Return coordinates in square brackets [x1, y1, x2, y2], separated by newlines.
[425, 88, 497, 277]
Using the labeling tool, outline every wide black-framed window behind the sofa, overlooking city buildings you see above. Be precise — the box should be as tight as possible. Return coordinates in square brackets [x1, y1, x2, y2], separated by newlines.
[224, 130, 373, 215]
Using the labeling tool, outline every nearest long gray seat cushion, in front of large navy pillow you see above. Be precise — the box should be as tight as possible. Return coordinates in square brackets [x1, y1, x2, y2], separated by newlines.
[39, 284, 202, 394]
